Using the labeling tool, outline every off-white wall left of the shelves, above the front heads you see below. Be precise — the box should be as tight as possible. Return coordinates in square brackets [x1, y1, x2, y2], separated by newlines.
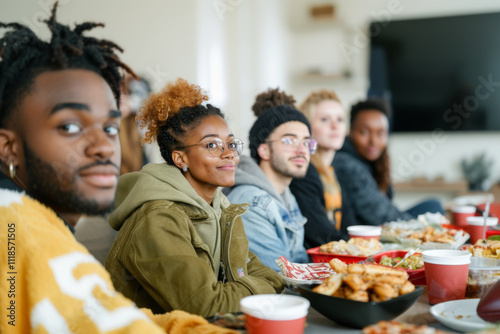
[0, 0, 288, 154]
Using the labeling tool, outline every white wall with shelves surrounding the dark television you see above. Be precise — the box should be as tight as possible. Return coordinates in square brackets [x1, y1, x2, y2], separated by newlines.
[284, 0, 500, 206]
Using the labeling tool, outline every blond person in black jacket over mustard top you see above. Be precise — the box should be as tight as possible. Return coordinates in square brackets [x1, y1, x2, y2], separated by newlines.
[290, 90, 349, 248]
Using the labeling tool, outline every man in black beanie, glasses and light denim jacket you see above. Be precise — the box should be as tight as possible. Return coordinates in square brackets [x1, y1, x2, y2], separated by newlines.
[227, 105, 316, 271]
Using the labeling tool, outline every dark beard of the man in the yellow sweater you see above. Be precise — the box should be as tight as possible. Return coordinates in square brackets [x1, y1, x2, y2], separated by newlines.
[23, 142, 114, 215]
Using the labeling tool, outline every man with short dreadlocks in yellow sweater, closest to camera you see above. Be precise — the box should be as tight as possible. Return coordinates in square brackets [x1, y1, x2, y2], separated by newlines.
[0, 4, 233, 333]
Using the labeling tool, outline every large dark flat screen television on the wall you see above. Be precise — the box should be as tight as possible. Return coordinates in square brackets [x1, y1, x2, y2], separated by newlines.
[368, 13, 500, 132]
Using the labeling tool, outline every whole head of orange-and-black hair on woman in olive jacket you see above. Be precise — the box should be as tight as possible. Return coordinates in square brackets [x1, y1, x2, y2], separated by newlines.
[136, 78, 224, 165]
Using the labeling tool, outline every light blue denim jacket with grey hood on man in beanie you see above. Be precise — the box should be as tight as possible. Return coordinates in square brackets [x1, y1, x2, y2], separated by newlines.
[224, 156, 308, 272]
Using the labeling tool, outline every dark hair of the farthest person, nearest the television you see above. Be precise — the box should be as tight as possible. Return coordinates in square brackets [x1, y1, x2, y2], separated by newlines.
[350, 99, 391, 193]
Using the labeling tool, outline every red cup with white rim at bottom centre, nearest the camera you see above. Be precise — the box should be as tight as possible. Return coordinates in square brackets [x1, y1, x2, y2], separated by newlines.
[240, 294, 310, 334]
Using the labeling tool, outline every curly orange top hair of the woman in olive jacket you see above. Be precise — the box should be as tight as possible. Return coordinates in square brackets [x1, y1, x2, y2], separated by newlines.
[135, 78, 208, 143]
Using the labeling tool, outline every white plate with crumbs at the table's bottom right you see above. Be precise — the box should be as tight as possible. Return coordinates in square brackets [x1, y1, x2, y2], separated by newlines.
[430, 298, 494, 332]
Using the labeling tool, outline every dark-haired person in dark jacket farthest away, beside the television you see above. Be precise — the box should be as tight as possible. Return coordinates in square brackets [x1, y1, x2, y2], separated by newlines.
[333, 100, 444, 228]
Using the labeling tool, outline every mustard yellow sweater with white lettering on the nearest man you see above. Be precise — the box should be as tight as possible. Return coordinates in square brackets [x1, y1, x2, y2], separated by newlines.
[0, 189, 235, 334]
